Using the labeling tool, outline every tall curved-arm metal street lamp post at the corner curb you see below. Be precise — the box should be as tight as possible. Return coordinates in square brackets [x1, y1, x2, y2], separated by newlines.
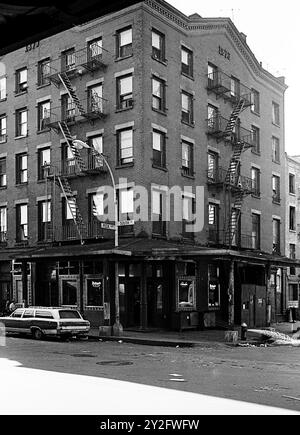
[73, 140, 123, 336]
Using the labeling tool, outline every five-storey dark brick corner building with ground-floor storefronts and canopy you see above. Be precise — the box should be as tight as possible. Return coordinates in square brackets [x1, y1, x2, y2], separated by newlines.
[0, 0, 293, 329]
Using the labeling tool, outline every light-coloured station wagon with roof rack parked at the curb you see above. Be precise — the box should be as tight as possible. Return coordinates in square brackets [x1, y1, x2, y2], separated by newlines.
[0, 307, 90, 340]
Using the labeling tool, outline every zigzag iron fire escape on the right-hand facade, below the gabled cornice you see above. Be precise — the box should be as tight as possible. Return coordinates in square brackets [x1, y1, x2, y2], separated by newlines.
[207, 70, 256, 248]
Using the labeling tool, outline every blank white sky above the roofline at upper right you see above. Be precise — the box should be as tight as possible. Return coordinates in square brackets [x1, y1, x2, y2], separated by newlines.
[167, 0, 300, 155]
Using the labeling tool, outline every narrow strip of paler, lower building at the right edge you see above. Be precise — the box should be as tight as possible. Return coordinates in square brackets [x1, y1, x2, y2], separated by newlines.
[286, 155, 300, 320]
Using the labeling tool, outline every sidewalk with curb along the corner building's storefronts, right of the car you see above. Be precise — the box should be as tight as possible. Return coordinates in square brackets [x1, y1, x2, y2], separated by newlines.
[89, 322, 300, 347]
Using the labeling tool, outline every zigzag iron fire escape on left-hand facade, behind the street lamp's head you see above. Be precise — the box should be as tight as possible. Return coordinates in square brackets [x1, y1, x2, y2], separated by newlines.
[46, 47, 106, 244]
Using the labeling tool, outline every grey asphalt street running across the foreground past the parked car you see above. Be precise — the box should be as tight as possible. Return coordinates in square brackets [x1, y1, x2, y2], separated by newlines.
[0, 337, 300, 414]
